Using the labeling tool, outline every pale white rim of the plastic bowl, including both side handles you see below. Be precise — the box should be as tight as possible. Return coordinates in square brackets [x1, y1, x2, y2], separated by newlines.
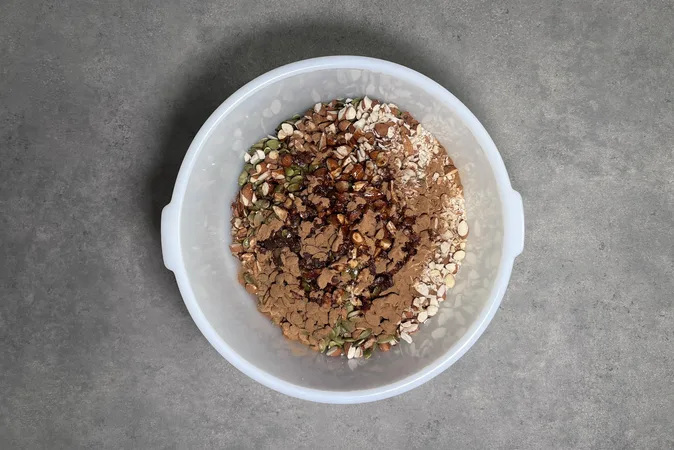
[161, 56, 524, 404]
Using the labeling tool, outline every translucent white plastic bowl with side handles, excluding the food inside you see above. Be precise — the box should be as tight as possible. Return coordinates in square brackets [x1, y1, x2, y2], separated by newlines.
[161, 56, 524, 403]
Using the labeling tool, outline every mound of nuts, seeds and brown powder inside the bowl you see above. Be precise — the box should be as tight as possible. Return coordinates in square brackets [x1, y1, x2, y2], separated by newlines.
[231, 97, 468, 358]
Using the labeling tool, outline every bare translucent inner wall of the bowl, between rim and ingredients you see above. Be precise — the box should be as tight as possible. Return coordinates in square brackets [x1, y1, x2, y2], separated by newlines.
[180, 68, 503, 392]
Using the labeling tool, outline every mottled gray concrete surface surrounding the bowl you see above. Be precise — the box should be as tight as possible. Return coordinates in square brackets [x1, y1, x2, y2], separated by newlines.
[0, 0, 674, 449]
